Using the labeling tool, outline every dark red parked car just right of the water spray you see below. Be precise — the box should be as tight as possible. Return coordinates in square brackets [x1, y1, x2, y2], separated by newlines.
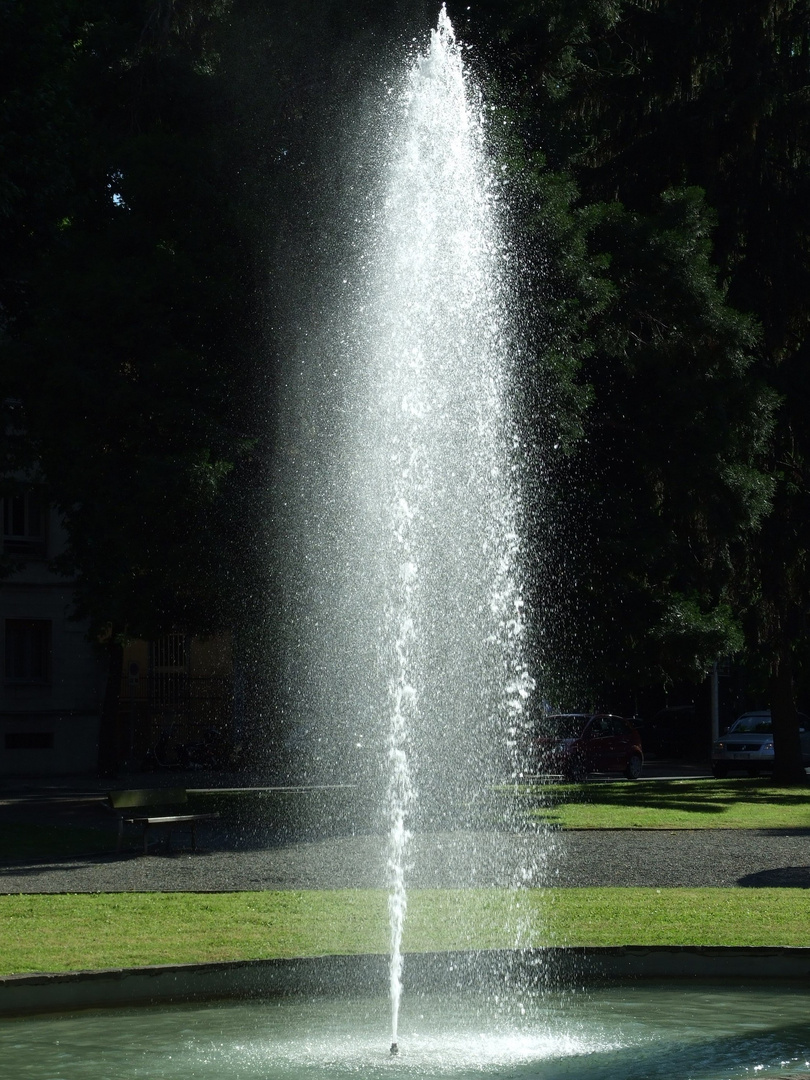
[531, 713, 644, 780]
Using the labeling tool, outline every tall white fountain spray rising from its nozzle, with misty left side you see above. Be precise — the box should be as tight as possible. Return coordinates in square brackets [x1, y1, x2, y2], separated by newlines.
[275, 0, 532, 1043]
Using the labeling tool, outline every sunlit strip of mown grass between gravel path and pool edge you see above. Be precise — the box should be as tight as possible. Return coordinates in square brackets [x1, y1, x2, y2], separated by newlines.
[0, 889, 810, 974]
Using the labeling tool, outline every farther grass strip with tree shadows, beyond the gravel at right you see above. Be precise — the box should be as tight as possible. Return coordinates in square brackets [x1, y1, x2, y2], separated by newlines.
[514, 778, 810, 829]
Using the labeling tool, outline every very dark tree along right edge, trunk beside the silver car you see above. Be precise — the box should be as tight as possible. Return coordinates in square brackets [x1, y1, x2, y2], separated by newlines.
[533, 0, 810, 783]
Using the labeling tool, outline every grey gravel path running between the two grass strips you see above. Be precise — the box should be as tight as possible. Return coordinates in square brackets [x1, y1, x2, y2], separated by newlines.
[0, 829, 810, 893]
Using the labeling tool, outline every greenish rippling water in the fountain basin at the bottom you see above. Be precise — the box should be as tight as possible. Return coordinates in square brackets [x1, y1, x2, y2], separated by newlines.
[6, 980, 810, 1080]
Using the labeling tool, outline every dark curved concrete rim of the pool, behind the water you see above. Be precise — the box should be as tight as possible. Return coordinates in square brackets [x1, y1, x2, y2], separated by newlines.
[0, 945, 810, 1016]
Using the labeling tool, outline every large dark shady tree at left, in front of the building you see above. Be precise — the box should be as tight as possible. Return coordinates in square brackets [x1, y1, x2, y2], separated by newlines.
[0, 0, 254, 769]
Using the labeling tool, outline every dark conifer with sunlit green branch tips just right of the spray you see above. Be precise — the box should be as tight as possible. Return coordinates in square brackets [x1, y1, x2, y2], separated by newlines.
[520, 179, 769, 697]
